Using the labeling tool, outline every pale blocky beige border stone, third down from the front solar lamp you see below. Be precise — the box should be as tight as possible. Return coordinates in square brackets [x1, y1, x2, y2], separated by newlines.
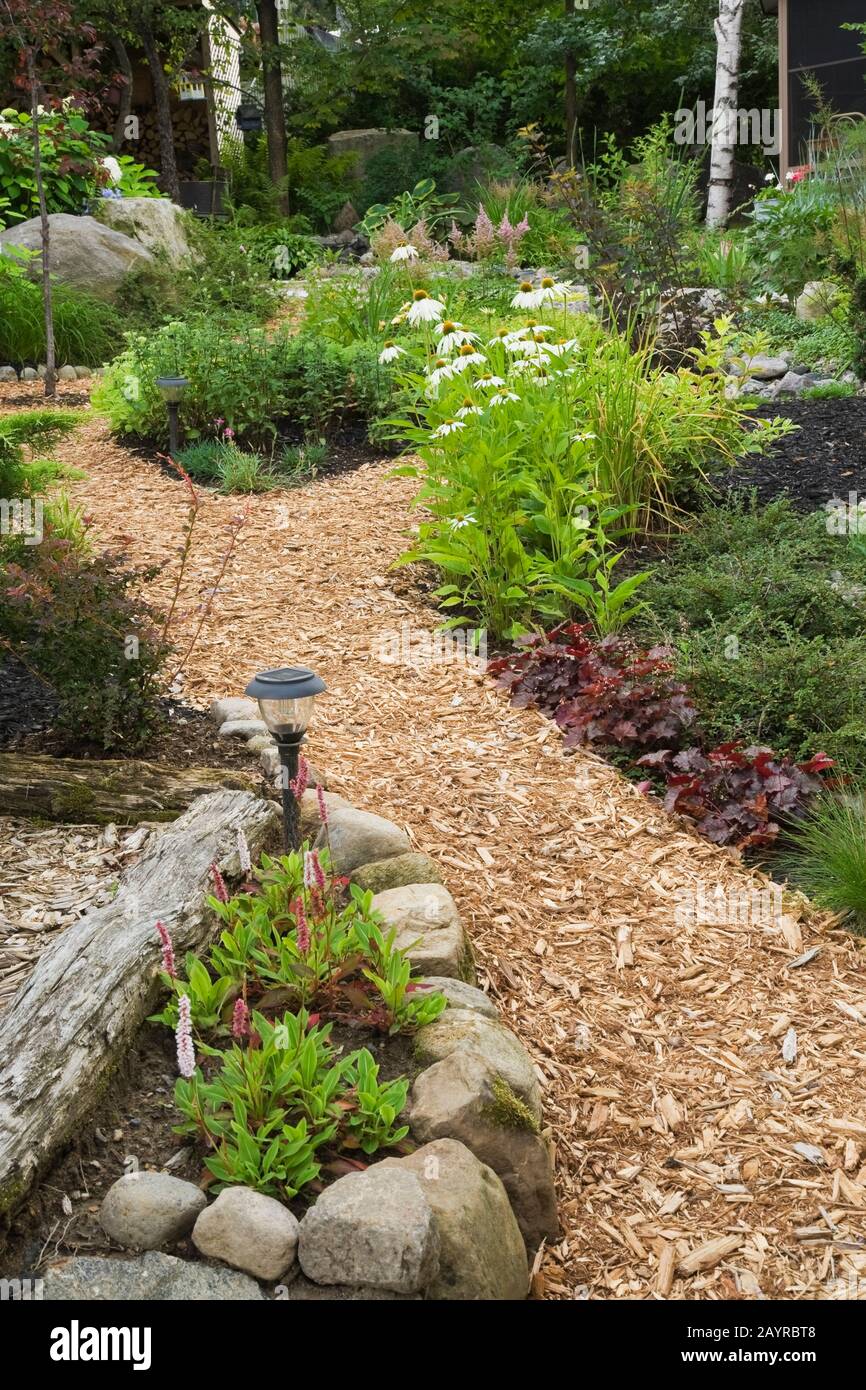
[373, 883, 475, 984]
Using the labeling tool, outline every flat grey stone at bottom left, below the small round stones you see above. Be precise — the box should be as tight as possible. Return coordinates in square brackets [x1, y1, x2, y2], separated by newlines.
[42, 1250, 264, 1302]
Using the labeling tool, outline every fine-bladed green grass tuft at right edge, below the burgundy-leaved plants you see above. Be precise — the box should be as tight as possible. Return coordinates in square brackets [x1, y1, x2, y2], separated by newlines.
[778, 792, 866, 934]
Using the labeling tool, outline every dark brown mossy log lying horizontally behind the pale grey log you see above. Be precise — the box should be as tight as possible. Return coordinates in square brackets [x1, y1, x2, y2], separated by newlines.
[0, 753, 256, 826]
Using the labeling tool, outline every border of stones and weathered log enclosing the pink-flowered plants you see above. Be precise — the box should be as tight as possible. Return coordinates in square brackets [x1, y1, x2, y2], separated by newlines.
[0, 701, 557, 1301]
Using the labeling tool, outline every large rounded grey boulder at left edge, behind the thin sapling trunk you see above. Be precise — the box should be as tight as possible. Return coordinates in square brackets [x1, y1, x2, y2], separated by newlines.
[0, 213, 153, 300]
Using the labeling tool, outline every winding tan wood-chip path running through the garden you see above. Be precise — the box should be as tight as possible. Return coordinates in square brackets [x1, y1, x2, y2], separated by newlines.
[10, 421, 866, 1300]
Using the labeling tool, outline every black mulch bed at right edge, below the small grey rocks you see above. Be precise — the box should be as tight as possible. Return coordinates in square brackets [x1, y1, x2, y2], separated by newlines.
[719, 396, 866, 512]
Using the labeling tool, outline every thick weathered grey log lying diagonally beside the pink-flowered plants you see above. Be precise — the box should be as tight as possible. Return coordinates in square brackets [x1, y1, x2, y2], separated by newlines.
[0, 791, 279, 1213]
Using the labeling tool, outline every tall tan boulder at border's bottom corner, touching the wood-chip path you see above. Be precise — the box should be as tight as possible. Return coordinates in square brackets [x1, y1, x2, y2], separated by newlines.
[381, 1138, 530, 1301]
